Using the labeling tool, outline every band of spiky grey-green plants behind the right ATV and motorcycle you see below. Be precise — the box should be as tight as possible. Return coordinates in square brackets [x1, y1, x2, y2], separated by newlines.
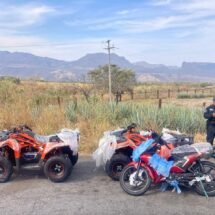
[66, 102, 205, 134]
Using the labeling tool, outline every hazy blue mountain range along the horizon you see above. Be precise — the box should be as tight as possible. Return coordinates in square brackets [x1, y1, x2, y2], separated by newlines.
[0, 51, 215, 82]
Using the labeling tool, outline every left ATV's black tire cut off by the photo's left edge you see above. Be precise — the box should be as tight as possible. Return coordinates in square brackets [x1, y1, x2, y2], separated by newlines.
[0, 156, 13, 183]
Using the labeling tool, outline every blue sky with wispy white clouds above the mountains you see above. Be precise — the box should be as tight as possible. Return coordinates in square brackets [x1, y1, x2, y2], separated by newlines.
[0, 0, 215, 65]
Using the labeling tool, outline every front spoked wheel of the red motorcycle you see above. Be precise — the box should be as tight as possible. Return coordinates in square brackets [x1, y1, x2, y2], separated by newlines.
[120, 165, 151, 196]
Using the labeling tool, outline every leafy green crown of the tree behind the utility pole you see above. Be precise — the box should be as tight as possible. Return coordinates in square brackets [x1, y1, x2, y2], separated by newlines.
[88, 65, 136, 101]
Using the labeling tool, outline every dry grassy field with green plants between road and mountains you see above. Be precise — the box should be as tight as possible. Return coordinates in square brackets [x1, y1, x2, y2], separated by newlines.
[0, 80, 214, 153]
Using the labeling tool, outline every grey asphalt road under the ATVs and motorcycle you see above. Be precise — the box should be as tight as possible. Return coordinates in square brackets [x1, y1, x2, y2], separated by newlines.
[0, 157, 215, 215]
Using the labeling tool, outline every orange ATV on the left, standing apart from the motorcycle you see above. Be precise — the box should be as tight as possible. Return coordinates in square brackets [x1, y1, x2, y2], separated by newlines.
[0, 126, 79, 183]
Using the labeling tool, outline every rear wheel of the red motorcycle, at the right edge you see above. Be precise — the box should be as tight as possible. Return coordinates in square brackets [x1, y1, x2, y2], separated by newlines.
[195, 161, 215, 196]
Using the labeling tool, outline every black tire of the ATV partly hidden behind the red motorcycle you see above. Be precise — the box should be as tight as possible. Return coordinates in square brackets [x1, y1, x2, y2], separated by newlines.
[105, 154, 131, 181]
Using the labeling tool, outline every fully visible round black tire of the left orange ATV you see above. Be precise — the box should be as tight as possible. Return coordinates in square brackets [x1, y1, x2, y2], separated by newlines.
[44, 156, 72, 182]
